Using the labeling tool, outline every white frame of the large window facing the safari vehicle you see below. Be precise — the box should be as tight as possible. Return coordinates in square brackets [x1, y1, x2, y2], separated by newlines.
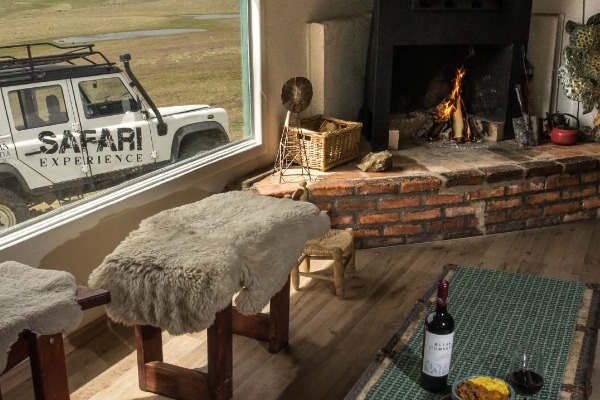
[0, 0, 265, 251]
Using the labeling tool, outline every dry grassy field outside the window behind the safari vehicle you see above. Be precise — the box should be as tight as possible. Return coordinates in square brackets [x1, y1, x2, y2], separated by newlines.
[0, 0, 243, 139]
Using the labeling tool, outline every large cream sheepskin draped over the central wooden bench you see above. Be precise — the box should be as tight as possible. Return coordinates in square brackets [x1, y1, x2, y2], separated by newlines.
[88, 191, 330, 335]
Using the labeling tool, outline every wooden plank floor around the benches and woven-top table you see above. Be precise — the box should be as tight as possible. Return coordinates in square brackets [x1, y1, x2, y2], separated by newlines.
[4, 220, 600, 400]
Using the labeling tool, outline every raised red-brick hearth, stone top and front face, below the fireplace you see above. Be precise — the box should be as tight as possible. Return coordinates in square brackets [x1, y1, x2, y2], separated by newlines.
[254, 140, 600, 248]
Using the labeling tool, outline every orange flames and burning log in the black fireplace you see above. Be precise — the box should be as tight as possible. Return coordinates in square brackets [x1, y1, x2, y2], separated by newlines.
[435, 66, 471, 141]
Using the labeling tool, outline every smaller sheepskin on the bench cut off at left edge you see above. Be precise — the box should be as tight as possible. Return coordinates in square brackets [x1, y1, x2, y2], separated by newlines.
[0, 261, 83, 372]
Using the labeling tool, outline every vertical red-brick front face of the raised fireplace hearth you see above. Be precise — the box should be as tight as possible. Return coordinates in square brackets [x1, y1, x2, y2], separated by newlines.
[308, 156, 600, 248]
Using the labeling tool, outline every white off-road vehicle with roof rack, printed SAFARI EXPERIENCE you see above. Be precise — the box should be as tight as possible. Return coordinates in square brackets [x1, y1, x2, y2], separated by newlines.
[0, 43, 229, 229]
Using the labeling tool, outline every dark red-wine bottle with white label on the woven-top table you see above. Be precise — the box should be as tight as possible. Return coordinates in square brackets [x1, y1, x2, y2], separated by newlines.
[420, 280, 454, 393]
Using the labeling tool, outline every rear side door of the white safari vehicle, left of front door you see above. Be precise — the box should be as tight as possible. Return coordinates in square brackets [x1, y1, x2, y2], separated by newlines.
[1, 81, 86, 188]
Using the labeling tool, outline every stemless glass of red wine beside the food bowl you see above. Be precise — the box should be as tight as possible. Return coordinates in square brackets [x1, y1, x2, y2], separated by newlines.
[509, 344, 544, 396]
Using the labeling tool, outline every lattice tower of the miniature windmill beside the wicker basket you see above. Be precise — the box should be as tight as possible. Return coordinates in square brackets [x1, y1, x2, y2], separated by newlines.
[274, 111, 311, 183]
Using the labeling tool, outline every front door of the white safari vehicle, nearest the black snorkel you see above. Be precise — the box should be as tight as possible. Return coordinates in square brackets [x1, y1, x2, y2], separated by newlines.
[71, 74, 155, 180]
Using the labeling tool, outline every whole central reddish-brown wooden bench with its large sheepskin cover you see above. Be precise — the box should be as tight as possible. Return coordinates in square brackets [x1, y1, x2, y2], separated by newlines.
[88, 191, 331, 400]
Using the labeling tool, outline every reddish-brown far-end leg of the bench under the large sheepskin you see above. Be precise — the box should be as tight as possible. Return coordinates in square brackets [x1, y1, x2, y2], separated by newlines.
[233, 277, 290, 353]
